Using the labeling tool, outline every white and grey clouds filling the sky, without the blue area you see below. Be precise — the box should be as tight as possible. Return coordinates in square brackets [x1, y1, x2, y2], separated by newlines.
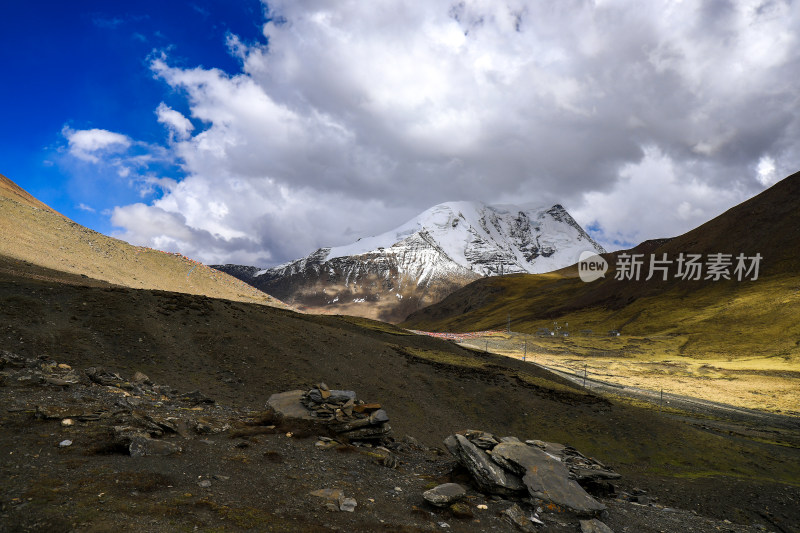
[68, 0, 800, 266]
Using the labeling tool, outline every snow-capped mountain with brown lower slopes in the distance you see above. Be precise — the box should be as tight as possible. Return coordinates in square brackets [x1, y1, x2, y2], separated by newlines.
[215, 202, 605, 321]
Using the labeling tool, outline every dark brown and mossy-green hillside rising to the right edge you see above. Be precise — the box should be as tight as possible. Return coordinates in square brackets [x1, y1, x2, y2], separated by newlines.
[403, 173, 800, 361]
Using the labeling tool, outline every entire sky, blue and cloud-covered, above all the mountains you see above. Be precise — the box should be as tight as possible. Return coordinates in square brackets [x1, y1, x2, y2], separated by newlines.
[0, 0, 800, 266]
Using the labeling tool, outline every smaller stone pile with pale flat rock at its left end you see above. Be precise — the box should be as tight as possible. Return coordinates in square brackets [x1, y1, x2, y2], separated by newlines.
[268, 383, 392, 441]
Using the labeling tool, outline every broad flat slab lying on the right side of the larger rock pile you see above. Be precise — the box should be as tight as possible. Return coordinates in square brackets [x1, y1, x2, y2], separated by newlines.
[492, 442, 606, 516]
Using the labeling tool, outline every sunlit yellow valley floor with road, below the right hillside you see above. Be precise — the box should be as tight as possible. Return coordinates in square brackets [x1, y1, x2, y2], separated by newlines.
[460, 332, 800, 417]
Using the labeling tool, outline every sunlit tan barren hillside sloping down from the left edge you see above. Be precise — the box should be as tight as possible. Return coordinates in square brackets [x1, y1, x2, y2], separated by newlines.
[0, 175, 285, 307]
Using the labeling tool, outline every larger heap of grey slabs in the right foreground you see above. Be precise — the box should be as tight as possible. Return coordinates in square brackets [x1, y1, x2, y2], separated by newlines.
[444, 430, 620, 516]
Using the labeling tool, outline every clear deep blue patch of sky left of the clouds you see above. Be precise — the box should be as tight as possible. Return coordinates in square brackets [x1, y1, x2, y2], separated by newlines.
[0, 0, 264, 233]
